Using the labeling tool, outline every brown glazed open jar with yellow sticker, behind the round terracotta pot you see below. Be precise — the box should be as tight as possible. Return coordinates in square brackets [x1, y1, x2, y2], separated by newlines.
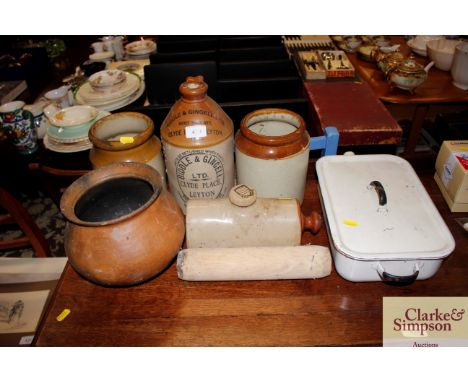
[88, 112, 166, 187]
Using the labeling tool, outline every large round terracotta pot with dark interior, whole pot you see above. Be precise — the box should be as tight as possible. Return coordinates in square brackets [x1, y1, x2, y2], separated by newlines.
[60, 163, 185, 285]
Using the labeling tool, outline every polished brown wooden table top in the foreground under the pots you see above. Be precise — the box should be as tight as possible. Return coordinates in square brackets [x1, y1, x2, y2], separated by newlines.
[35, 161, 468, 346]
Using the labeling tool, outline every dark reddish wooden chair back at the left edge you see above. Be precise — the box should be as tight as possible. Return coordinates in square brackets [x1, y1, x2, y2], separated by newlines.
[0, 187, 50, 257]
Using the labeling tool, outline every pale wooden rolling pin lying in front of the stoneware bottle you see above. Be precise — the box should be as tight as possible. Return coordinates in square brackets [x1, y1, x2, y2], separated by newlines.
[177, 245, 332, 281]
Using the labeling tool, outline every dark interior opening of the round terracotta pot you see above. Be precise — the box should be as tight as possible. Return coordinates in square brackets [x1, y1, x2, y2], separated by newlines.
[75, 177, 154, 222]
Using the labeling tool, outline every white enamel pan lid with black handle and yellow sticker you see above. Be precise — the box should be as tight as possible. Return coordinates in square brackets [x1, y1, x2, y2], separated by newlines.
[316, 155, 455, 260]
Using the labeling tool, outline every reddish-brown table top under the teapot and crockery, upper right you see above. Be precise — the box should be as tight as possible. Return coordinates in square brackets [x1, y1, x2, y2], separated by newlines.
[346, 36, 468, 104]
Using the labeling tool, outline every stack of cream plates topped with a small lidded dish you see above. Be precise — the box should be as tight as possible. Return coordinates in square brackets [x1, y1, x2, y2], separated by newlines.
[75, 70, 145, 111]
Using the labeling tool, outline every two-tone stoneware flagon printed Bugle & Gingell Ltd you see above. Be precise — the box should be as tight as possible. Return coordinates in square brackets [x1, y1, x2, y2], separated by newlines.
[161, 76, 234, 213]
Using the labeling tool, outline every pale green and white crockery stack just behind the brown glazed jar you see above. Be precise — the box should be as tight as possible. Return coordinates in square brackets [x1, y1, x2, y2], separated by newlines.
[44, 105, 110, 153]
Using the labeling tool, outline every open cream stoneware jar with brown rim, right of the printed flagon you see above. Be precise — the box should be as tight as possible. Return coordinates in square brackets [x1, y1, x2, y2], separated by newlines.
[236, 109, 310, 203]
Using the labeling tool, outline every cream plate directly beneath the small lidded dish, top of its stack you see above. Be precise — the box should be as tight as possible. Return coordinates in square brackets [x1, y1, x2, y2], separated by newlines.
[75, 72, 141, 106]
